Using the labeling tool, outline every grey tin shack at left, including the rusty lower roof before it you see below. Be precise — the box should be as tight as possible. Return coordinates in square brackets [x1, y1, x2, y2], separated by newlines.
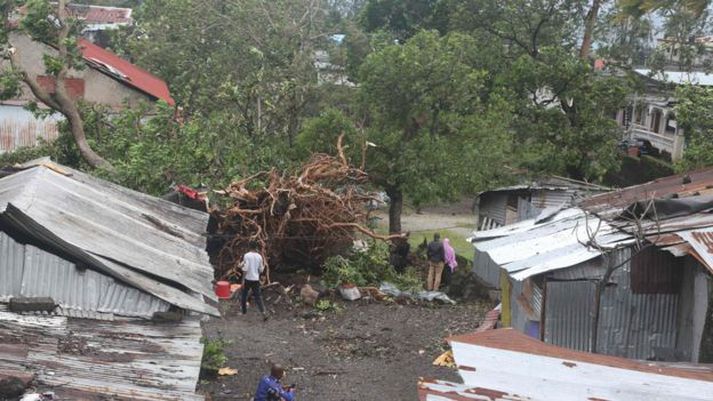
[0, 160, 218, 400]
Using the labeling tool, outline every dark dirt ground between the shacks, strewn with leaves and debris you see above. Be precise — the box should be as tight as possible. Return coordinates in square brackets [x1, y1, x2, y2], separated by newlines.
[201, 284, 491, 401]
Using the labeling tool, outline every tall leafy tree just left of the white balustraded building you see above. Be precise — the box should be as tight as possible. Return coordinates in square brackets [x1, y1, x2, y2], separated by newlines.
[450, 0, 629, 180]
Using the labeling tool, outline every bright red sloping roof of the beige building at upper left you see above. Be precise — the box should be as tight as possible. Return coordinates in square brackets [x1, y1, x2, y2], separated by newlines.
[79, 39, 176, 106]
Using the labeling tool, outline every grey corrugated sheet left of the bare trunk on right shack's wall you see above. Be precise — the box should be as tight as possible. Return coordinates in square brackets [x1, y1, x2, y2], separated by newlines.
[545, 281, 596, 351]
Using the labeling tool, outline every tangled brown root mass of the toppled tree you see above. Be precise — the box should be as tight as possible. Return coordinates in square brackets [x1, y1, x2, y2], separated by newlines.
[209, 137, 390, 280]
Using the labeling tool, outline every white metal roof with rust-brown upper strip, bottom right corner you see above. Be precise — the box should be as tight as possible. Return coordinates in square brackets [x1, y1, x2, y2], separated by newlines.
[444, 329, 713, 401]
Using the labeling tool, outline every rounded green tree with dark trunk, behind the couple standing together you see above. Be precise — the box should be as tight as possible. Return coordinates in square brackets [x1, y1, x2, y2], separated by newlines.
[360, 32, 510, 232]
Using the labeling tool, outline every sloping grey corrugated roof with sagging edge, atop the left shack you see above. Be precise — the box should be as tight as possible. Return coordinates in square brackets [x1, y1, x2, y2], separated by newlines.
[0, 164, 218, 315]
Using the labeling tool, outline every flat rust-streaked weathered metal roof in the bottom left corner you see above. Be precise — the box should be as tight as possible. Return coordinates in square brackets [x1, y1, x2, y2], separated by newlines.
[0, 310, 204, 401]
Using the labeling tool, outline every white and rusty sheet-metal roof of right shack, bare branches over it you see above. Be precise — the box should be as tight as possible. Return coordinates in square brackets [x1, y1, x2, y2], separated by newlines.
[472, 168, 713, 280]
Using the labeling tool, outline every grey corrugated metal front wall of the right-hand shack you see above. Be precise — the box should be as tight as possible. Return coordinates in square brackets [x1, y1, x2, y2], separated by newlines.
[545, 249, 679, 360]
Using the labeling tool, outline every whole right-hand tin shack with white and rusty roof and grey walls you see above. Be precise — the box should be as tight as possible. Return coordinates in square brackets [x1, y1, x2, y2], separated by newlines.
[473, 169, 713, 362]
